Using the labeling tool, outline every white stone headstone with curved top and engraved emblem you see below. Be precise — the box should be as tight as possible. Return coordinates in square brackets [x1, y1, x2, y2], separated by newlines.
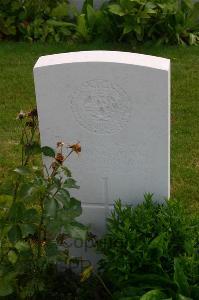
[34, 51, 170, 264]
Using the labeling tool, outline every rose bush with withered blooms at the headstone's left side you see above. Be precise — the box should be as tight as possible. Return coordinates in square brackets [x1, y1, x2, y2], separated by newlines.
[0, 109, 87, 299]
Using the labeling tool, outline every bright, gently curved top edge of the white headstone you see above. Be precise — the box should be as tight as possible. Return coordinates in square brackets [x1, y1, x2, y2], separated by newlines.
[34, 50, 170, 71]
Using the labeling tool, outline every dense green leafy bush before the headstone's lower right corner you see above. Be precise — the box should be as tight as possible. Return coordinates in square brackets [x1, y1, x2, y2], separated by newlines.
[98, 195, 199, 300]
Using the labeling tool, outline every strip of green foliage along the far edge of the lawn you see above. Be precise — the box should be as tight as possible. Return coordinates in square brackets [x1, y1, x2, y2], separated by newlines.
[0, 0, 199, 45]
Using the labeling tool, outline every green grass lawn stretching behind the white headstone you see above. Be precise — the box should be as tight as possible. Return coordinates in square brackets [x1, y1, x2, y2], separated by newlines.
[0, 42, 199, 211]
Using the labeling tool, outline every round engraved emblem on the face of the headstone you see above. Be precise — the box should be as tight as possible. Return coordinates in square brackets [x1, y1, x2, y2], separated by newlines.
[71, 79, 131, 134]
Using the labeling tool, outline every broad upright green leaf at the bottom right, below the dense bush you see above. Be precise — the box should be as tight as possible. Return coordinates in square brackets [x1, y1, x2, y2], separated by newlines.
[174, 258, 190, 297]
